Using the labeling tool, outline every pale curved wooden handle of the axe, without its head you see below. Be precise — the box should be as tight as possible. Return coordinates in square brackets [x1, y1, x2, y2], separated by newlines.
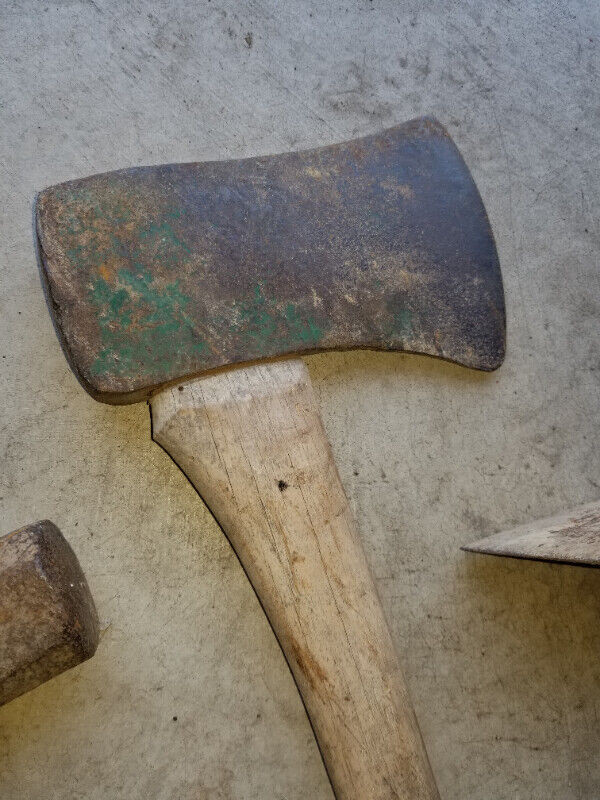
[151, 360, 438, 800]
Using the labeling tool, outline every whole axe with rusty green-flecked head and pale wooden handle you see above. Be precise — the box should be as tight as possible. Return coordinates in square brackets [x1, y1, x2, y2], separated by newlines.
[35, 118, 505, 800]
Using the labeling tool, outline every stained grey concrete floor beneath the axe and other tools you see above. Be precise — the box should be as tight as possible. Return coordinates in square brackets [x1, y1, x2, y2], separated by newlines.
[0, 0, 600, 800]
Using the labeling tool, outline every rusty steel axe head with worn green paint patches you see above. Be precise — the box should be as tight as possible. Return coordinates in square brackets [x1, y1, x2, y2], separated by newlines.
[35, 118, 505, 403]
